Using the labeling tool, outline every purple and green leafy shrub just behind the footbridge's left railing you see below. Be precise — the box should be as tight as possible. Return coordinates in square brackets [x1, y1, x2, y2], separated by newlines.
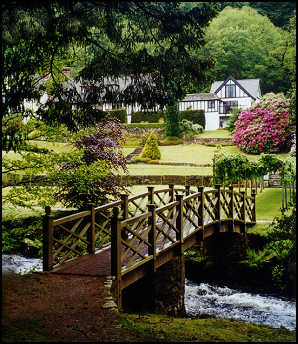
[49, 119, 126, 208]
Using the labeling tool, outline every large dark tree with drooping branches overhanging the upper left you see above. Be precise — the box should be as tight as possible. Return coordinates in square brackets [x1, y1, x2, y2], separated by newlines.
[1, 0, 218, 149]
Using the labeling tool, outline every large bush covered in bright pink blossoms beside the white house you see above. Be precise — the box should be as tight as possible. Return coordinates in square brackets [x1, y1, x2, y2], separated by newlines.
[233, 93, 292, 154]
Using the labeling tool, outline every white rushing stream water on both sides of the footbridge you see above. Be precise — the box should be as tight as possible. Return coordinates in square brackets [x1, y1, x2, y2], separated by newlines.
[2, 254, 296, 330]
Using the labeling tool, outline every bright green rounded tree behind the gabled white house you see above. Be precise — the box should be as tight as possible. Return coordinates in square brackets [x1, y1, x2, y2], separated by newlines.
[204, 6, 290, 93]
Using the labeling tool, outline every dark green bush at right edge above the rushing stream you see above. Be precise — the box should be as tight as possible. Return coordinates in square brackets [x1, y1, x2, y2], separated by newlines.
[266, 202, 296, 292]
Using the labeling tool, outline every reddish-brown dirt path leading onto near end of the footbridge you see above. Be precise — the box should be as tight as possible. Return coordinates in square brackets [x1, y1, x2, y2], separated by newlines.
[2, 273, 151, 342]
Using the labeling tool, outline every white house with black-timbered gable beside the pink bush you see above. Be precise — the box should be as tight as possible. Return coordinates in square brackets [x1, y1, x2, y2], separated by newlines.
[179, 76, 261, 130]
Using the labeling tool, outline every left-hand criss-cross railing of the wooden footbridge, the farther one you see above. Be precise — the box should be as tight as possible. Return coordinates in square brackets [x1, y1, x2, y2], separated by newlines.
[43, 184, 189, 271]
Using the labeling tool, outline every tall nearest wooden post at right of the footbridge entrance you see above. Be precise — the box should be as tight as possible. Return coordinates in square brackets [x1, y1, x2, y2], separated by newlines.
[111, 207, 122, 308]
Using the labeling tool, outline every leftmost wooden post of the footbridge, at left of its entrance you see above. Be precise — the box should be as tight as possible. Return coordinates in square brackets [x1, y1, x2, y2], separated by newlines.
[42, 206, 53, 271]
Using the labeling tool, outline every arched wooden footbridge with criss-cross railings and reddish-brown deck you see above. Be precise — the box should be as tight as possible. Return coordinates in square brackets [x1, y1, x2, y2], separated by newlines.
[43, 185, 256, 308]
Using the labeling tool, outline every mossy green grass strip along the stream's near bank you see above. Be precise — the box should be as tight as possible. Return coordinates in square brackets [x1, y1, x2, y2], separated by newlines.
[121, 314, 296, 342]
